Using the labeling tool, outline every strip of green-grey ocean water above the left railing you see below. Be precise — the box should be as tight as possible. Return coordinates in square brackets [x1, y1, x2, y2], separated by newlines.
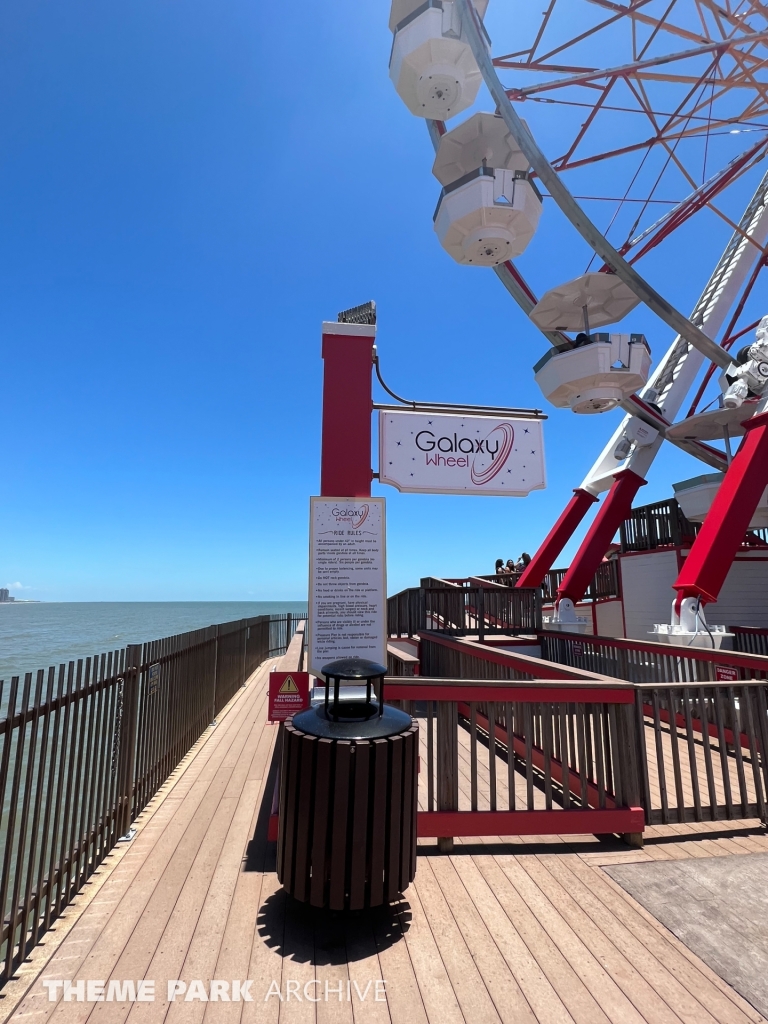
[0, 601, 306, 680]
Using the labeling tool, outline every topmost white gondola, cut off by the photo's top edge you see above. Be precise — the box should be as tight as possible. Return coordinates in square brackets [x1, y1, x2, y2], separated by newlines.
[389, 0, 490, 121]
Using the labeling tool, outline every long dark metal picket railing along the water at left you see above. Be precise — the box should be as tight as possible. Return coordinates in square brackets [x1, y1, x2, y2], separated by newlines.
[0, 613, 300, 985]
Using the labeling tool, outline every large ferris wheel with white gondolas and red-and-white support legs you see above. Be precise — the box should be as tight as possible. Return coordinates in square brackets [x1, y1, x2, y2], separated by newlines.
[389, 0, 768, 644]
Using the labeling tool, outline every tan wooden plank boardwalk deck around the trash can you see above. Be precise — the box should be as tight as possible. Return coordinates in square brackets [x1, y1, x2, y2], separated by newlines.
[6, 662, 768, 1024]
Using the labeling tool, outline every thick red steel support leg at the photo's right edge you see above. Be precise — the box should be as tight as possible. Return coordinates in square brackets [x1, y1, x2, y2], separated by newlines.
[673, 413, 768, 607]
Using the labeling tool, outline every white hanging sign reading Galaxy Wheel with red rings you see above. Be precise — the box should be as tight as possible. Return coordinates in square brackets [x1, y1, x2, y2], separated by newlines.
[379, 410, 547, 498]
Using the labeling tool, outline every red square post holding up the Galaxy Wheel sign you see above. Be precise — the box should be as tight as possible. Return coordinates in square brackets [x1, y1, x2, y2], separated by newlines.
[321, 323, 376, 498]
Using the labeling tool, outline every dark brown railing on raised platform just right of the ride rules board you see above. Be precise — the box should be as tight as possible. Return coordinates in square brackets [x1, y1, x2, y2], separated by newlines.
[387, 586, 542, 637]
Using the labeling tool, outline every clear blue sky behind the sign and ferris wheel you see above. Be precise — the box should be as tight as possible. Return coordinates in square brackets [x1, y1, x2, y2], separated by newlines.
[0, 0, 768, 600]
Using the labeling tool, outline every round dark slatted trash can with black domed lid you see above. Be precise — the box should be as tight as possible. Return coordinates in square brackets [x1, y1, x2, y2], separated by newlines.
[278, 657, 419, 910]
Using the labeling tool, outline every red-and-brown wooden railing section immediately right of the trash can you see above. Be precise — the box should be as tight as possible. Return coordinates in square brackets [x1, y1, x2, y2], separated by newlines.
[384, 679, 644, 838]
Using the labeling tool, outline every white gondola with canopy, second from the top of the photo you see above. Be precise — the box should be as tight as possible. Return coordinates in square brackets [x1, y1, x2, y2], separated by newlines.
[432, 114, 542, 266]
